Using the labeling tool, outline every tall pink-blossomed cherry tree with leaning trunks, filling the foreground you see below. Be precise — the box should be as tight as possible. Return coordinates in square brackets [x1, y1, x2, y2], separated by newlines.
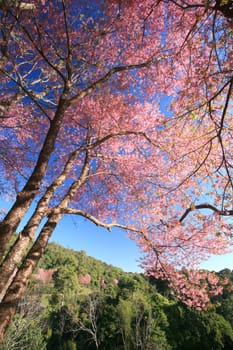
[0, 0, 233, 339]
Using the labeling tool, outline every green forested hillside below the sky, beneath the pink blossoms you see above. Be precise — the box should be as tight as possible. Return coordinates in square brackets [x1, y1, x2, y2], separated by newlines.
[0, 243, 233, 350]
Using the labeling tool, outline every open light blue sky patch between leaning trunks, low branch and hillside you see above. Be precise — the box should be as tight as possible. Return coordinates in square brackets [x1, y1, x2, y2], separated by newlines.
[51, 216, 142, 272]
